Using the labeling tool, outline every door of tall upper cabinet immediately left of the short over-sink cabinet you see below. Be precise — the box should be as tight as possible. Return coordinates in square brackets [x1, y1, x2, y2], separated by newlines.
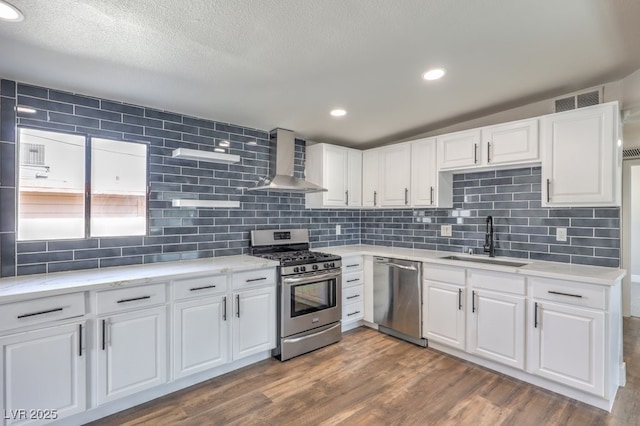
[411, 138, 438, 207]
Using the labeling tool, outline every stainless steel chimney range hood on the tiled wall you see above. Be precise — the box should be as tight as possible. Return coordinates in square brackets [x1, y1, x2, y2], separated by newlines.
[247, 129, 326, 193]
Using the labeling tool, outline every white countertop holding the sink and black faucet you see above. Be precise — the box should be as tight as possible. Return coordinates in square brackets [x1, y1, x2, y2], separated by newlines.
[321, 245, 627, 286]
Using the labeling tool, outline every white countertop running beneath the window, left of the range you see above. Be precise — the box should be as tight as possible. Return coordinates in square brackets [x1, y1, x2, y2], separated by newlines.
[0, 255, 278, 303]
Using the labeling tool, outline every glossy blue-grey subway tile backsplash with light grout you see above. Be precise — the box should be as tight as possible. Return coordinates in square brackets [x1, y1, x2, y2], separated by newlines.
[0, 80, 620, 276]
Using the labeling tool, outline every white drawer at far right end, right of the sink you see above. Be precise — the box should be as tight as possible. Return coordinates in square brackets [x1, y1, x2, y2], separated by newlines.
[529, 278, 607, 309]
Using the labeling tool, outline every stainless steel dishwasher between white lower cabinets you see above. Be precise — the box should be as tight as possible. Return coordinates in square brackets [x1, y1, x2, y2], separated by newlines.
[373, 257, 427, 346]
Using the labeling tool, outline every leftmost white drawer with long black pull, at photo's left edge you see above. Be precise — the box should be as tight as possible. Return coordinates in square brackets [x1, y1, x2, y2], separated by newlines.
[0, 293, 86, 330]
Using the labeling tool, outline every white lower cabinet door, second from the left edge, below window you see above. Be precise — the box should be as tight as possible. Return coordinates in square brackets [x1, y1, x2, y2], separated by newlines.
[96, 306, 167, 404]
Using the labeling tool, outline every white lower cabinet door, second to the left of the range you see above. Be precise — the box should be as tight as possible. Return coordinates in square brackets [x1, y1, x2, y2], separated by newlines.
[173, 296, 229, 378]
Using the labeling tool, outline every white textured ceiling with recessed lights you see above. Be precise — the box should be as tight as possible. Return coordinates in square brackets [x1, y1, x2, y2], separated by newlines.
[0, 0, 640, 146]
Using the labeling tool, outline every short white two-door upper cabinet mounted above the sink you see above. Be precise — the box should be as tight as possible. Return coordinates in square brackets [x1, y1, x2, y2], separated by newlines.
[437, 119, 540, 170]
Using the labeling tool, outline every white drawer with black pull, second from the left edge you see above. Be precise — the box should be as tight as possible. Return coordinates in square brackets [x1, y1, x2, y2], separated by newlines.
[96, 284, 167, 315]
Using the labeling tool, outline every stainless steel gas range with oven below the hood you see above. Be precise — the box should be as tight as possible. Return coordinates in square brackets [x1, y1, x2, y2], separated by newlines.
[250, 229, 342, 361]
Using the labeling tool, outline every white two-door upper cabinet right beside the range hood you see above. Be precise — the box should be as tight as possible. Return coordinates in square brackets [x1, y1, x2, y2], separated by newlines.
[306, 143, 362, 207]
